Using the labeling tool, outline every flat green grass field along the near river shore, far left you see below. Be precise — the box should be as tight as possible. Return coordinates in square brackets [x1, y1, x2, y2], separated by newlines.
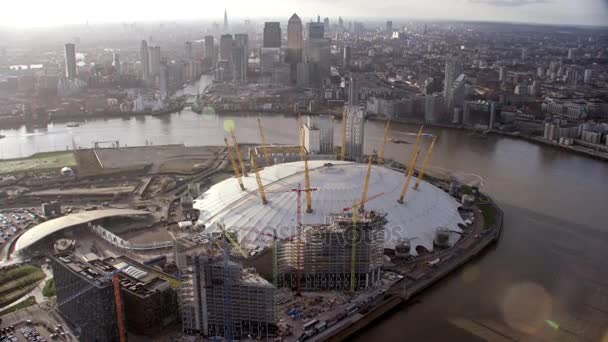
[0, 152, 78, 174]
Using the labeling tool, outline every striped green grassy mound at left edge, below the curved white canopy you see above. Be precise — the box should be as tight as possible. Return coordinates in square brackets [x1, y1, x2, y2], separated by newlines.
[0, 265, 45, 307]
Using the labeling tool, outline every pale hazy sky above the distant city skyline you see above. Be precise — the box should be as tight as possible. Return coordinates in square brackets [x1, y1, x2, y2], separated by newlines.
[0, 0, 608, 27]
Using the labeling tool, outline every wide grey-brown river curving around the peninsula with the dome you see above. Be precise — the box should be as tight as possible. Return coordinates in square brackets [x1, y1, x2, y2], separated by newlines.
[0, 77, 608, 341]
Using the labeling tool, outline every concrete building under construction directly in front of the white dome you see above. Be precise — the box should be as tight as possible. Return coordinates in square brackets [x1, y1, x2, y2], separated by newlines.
[277, 211, 387, 291]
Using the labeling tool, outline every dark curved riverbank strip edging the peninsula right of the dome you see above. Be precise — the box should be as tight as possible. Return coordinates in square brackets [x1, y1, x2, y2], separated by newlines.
[324, 191, 504, 342]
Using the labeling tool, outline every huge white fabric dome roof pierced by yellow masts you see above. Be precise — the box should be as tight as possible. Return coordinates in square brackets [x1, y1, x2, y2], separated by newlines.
[194, 160, 463, 255]
